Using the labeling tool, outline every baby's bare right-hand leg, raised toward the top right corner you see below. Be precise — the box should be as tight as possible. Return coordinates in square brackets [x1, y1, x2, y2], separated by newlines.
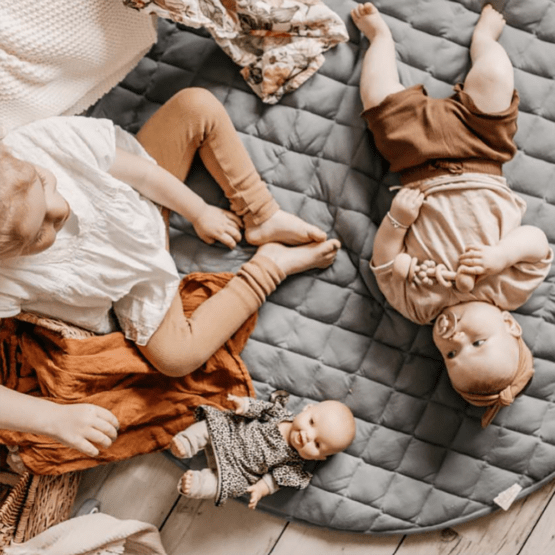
[464, 4, 514, 113]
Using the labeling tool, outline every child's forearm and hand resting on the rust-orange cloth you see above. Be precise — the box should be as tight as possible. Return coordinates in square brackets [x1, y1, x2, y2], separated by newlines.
[0, 386, 119, 457]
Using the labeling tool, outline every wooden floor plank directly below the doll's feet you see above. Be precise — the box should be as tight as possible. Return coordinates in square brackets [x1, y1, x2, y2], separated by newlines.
[161, 496, 285, 555]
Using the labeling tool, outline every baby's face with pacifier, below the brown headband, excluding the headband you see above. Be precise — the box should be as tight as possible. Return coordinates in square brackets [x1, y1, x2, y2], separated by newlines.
[433, 301, 521, 393]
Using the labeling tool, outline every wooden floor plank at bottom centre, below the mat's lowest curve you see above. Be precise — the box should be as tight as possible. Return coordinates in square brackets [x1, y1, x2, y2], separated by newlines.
[272, 523, 402, 555]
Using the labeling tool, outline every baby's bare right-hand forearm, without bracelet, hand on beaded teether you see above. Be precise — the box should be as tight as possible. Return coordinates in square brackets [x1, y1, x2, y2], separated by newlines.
[458, 225, 549, 275]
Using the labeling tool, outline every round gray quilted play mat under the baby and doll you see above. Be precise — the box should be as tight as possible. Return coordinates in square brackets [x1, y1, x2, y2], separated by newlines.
[92, 0, 555, 534]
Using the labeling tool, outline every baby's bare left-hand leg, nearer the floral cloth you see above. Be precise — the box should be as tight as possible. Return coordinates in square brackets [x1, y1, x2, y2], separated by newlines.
[351, 2, 404, 110]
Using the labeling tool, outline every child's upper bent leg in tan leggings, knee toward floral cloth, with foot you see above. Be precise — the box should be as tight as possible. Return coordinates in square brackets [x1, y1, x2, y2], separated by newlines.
[137, 88, 326, 245]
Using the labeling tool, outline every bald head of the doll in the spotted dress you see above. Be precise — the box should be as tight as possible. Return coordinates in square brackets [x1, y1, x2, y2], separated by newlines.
[289, 401, 355, 460]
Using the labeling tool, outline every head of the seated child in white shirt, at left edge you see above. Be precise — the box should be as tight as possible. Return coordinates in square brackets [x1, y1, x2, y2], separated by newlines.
[0, 145, 70, 259]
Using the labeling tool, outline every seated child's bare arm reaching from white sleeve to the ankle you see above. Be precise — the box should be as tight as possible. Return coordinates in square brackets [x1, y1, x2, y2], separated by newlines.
[110, 148, 243, 249]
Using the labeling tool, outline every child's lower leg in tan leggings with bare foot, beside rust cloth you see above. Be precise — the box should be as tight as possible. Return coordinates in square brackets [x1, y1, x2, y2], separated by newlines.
[137, 239, 340, 377]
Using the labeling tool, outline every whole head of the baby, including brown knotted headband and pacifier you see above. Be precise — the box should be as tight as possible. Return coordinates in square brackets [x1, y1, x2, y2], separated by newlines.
[433, 301, 534, 425]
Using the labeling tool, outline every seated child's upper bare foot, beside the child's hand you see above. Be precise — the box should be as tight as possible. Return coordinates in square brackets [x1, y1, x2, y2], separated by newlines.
[245, 210, 327, 246]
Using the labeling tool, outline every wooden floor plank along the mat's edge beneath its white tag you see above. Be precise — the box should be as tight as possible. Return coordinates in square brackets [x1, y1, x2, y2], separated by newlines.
[395, 482, 555, 555]
